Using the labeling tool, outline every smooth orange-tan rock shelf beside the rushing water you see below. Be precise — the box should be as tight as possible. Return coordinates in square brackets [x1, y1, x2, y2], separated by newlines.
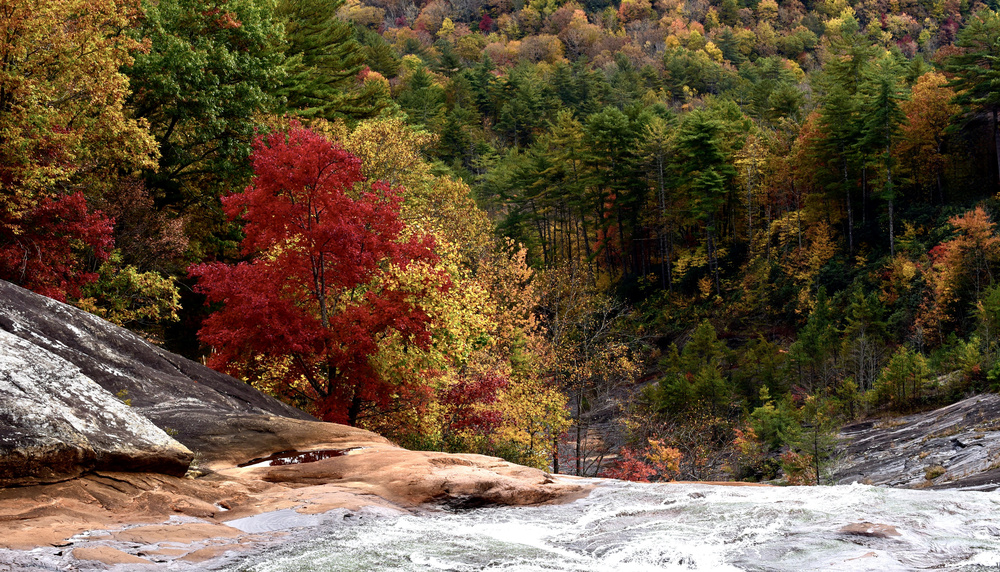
[0, 418, 591, 563]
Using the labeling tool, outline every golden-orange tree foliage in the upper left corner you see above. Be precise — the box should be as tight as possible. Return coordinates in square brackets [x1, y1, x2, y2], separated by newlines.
[0, 0, 157, 215]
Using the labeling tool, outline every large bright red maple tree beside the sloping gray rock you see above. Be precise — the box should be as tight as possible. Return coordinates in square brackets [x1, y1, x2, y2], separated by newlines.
[190, 125, 436, 425]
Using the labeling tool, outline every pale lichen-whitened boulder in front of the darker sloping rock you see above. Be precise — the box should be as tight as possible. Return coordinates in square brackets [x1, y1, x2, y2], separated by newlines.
[0, 330, 194, 486]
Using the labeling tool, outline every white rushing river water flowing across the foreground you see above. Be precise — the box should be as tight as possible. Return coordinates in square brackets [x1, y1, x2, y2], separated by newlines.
[231, 482, 1000, 572]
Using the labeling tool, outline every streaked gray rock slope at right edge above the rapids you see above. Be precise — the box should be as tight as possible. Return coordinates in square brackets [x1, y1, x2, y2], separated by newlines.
[833, 394, 1000, 491]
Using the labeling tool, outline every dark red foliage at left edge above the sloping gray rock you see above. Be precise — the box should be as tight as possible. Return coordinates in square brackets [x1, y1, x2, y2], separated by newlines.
[0, 192, 114, 301]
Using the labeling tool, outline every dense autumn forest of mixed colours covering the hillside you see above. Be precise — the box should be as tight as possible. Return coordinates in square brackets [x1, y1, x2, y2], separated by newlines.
[0, 0, 1000, 483]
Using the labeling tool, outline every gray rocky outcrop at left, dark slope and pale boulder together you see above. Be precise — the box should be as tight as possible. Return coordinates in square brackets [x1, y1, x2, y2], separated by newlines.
[0, 281, 315, 476]
